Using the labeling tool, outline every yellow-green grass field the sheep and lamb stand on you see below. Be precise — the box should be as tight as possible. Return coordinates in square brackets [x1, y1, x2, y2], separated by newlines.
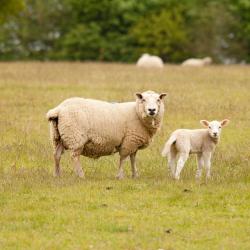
[0, 63, 250, 250]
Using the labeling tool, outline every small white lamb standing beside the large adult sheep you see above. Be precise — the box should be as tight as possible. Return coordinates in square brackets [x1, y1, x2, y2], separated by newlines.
[162, 119, 229, 180]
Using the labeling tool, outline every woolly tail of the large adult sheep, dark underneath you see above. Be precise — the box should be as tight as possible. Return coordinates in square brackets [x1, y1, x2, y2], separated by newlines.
[46, 108, 61, 146]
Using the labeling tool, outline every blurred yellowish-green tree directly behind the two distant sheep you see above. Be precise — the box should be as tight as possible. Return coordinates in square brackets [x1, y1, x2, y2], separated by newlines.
[130, 8, 188, 62]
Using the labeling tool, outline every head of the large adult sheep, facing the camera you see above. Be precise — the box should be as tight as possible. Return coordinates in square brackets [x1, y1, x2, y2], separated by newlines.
[135, 91, 167, 118]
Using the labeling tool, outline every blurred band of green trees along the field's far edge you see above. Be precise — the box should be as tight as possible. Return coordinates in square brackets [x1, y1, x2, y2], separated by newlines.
[0, 0, 250, 63]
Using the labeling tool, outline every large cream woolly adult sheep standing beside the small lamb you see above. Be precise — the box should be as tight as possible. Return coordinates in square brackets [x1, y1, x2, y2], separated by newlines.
[47, 91, 166, 179]
